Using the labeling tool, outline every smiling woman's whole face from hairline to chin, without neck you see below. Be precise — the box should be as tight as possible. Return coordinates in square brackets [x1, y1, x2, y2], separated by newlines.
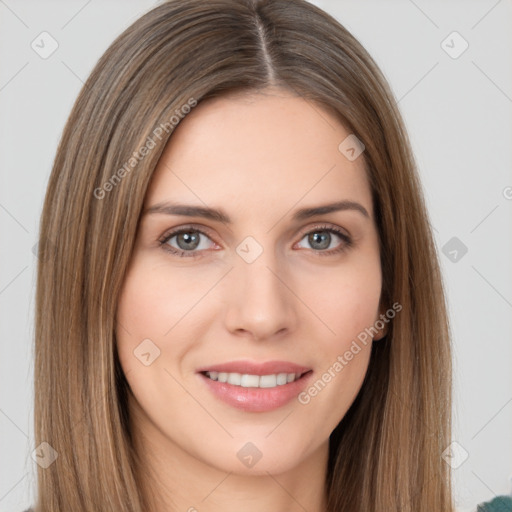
[116, 90, 381, 474]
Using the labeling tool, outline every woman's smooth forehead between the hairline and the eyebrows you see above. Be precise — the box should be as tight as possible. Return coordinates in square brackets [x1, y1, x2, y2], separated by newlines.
[146, 91, 372, 217]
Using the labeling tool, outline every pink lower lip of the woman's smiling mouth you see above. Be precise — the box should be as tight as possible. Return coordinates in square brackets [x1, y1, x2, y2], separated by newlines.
[199, 370, 313, 412]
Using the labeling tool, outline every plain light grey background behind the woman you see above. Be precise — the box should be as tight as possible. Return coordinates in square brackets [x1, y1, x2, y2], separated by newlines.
[0, 0, 512, 512]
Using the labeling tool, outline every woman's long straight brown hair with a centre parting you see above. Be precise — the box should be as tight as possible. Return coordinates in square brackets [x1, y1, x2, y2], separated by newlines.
[35, 0, 453, 512]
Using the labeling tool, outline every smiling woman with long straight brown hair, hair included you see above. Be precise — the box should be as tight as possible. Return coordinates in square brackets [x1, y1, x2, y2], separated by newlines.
[35, 0, 454, 512]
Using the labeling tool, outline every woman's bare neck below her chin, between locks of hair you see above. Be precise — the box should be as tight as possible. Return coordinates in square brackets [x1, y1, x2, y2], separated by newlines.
[132, 400, 329, 512]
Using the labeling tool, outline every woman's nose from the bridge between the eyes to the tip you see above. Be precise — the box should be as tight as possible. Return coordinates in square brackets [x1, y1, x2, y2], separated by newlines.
[226, 237, 296, 338]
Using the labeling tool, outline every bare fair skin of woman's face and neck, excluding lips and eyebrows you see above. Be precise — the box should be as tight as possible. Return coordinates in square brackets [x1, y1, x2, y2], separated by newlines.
[116, 89, 385, 512]
